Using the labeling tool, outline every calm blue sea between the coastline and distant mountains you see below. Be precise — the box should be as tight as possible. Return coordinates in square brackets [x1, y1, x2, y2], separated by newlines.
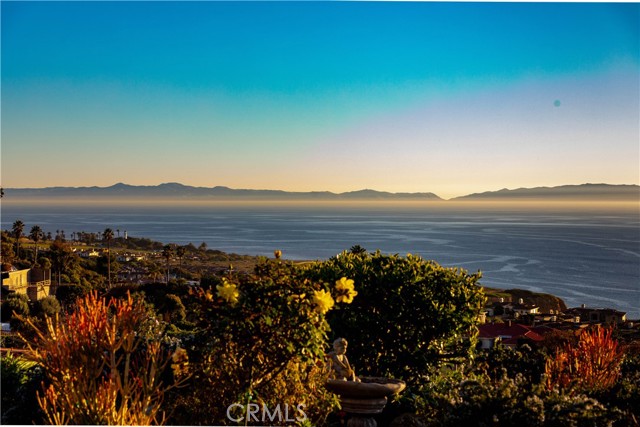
[1, 202, 640, 319]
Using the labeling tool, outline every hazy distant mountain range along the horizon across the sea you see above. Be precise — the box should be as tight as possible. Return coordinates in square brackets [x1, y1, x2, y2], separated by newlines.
[4, 183, 640, 201]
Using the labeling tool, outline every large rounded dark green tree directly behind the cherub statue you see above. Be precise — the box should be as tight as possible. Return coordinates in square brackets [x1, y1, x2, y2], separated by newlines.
[307, 251, 485, 385]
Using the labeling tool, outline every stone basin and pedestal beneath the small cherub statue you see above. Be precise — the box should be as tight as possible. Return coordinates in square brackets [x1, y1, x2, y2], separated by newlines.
[326, 377, 406, 427]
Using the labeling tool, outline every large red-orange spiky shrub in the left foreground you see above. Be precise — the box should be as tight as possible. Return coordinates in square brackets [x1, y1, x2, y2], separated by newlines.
[18, 292, 184, 425]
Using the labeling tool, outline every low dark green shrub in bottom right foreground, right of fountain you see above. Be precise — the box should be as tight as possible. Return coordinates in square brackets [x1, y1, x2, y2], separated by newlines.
[414, 353, 634, 427]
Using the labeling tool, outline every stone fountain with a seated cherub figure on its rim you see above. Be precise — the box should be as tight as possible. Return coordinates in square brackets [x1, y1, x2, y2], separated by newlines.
[326, 338, 406, 427]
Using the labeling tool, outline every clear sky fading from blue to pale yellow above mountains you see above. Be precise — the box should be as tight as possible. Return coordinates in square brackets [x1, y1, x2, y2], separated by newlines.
[0, 1, 640, 198]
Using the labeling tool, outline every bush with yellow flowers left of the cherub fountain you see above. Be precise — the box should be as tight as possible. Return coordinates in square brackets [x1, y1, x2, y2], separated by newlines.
[171, 259, 338, 425]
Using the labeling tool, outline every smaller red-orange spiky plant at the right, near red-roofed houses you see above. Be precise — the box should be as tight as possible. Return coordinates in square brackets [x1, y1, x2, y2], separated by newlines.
[545, 326, 624, 391]
